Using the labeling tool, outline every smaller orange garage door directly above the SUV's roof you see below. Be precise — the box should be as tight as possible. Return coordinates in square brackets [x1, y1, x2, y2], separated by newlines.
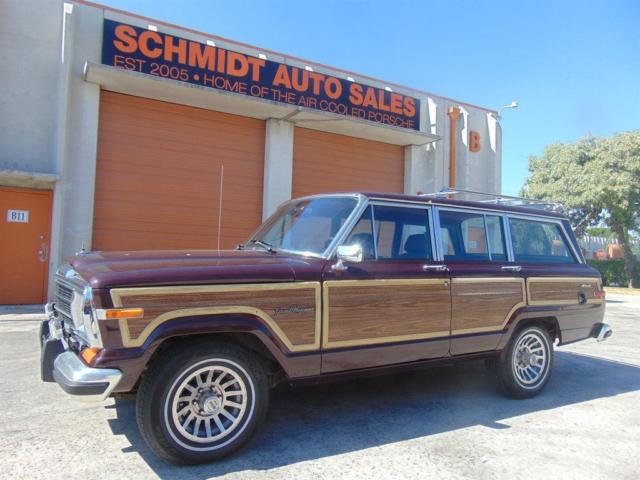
[293, 128, 404, 197]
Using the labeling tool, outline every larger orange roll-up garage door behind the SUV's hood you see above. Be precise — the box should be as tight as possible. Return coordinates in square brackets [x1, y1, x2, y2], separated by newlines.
[92, 91, 265, 250]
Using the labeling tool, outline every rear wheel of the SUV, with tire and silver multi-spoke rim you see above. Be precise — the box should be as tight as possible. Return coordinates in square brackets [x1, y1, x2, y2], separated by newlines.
[488, 325, 553, 398]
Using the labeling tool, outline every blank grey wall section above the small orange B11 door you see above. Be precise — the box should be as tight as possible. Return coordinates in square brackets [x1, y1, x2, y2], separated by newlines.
[0, 0, 62, 173]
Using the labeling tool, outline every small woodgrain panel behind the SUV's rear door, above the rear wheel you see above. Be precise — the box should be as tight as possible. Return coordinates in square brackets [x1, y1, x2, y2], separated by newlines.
[527, 277, 602, 305]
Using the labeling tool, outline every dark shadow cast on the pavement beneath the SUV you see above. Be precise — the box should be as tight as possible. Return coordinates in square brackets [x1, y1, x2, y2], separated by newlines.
[110, 352, 640, 479]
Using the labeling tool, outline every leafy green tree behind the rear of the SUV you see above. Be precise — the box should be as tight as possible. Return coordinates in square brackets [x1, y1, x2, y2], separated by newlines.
[522, 131, 640, 287]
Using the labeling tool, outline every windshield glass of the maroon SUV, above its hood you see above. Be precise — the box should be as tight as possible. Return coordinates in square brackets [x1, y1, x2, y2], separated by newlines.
[245, 197, 358, 255]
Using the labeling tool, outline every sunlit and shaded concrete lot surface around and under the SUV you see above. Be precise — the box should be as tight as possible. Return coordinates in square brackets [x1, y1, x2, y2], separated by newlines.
[0, 295, 640, 480]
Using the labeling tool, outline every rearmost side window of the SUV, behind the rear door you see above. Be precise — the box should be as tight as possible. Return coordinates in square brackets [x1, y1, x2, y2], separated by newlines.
[509, 218, 576, 263]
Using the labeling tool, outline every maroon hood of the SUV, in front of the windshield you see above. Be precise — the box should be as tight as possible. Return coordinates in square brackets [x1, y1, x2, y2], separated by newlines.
[69, 250, 323, 288]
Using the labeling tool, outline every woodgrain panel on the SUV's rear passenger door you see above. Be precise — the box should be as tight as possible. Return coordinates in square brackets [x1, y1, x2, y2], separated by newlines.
[451, 278, 526, 335]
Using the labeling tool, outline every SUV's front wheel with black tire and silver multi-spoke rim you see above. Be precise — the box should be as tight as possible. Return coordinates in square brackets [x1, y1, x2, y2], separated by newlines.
[136, 342, 269, 464]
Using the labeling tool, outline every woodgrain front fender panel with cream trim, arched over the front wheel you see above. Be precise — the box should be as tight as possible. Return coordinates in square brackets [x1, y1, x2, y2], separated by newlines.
[111, 282, 321, 351]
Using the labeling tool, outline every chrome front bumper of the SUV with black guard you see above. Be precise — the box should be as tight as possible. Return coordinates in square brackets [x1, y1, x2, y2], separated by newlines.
[40, 304, 122, 401]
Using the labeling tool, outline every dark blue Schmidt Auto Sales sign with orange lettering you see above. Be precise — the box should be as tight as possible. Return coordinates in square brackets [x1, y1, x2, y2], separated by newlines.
[102, 20, 420, 130]
